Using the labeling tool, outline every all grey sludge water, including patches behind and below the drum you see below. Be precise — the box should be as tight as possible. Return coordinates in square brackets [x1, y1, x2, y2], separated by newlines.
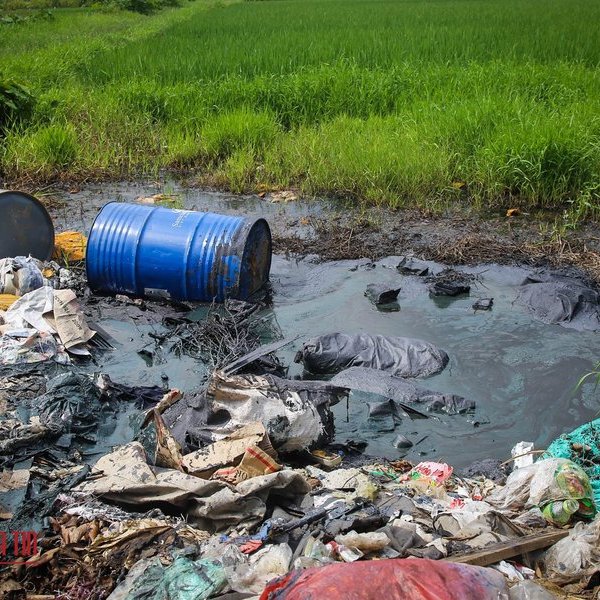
[54, 188, 600, 467]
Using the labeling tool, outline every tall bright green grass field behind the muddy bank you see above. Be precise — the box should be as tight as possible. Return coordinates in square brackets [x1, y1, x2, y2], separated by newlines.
[0, 0, 600, 217]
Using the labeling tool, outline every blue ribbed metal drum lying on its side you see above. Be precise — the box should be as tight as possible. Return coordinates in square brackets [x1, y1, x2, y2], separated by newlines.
[86, 202, 271, 302]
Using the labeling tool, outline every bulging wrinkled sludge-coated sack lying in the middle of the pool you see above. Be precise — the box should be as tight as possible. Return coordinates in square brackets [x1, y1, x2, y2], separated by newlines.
[295, 333, 449, 377]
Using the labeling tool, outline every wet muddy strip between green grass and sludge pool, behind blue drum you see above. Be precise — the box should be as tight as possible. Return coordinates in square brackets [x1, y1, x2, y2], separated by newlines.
[42, 182, 600, 282]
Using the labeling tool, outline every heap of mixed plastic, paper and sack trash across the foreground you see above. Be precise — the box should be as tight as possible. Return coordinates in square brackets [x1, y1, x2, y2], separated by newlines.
[0, 199, 600, 600]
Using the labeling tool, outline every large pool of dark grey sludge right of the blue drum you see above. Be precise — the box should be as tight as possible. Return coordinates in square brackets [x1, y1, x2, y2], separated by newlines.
[272, 257, 600, 467]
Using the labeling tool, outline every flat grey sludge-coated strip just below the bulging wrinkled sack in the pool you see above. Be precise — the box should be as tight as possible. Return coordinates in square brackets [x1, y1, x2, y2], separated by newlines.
[331, 367, 475, 415]
